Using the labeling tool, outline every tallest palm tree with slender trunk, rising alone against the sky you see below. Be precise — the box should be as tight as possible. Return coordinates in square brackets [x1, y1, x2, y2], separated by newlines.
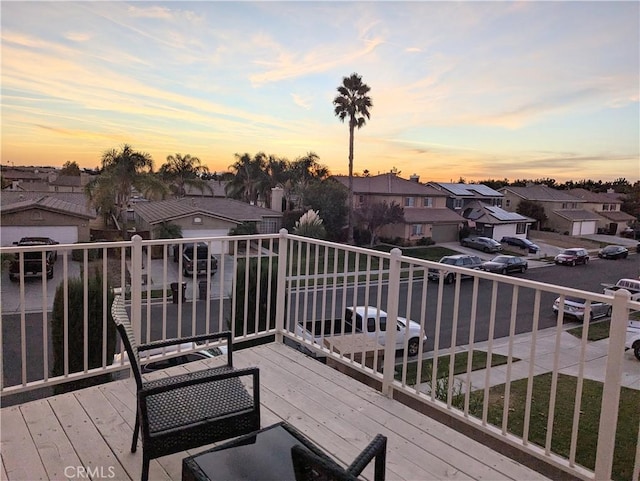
[333, 73, 373, 244]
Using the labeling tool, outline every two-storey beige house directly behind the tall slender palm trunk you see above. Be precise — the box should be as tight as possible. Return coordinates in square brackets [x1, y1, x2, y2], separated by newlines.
[334, 173, 464, 242]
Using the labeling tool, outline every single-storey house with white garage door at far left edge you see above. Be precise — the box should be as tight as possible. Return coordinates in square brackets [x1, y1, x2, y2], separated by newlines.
[0, 191, 96, 246]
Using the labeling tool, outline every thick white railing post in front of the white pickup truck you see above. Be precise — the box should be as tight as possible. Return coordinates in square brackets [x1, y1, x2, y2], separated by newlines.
[382, 248, 402, 397]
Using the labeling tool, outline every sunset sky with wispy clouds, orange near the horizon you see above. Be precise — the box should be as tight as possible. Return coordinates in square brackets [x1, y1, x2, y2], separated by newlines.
[0, 1, 640, 182]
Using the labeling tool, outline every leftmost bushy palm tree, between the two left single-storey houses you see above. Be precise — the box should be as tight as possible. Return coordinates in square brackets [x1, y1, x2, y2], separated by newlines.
[85, 144, 169, 239]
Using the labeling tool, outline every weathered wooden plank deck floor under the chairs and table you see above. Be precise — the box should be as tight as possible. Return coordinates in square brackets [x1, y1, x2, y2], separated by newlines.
[0, 343, 547, 481]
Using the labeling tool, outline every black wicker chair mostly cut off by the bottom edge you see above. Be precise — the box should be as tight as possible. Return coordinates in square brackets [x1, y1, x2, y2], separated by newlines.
[291, 434, 387, 481]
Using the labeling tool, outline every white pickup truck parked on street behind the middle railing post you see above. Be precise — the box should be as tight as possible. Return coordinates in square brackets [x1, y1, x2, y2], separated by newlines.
[296, 306, 427, 356]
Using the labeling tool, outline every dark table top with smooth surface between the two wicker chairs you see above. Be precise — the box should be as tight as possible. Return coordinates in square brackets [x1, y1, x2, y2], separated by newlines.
[182, 422, 319, 481]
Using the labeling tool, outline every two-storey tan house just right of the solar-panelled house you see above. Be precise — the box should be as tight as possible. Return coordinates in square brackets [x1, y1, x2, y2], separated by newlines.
[499, 185, 600, 236]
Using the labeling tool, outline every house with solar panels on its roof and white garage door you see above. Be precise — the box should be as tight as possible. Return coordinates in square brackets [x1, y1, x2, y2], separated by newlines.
[462, 200, 536, 241]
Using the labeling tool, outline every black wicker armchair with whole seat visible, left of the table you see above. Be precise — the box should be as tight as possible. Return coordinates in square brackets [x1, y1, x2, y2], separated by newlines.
[111, 296, 260, 481]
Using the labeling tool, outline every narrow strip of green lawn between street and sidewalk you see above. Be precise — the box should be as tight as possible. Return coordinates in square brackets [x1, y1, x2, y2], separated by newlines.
[395, 351, 519, 385]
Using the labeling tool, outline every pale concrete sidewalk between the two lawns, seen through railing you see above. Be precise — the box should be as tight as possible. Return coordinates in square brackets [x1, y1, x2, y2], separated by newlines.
[420, 327, 640, 392]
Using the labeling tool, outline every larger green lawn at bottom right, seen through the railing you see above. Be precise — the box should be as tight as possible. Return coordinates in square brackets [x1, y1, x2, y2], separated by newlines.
[470, 373, 640, 480]
